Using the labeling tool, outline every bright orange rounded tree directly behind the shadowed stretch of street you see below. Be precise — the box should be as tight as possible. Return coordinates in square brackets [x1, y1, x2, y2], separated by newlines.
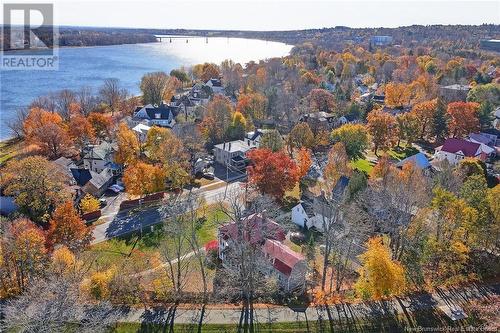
[123, 162, 166, 196]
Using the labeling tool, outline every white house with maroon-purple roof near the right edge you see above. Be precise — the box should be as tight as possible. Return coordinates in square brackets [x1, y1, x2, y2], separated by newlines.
[434, 138, 491, 165]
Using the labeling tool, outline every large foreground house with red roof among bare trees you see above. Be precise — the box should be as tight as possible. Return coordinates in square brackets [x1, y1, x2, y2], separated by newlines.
[217, 213, 307, 291]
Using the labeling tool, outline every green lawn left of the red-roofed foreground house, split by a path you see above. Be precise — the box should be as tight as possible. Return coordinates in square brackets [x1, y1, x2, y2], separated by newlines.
[87, 206, 227, 269]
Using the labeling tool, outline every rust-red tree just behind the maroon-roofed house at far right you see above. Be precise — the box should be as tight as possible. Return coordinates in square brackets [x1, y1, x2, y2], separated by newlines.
[446, 102, 479, 137]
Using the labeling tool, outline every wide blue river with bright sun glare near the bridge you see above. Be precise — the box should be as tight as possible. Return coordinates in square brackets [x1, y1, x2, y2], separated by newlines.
[0, 37, 292, 139]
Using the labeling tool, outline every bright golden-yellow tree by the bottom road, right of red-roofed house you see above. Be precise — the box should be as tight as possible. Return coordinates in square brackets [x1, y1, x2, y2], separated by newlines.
[355, 237, 405, 299]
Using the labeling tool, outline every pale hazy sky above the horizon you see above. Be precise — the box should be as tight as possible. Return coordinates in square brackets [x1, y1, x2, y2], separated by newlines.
[1, 0, 500, 30]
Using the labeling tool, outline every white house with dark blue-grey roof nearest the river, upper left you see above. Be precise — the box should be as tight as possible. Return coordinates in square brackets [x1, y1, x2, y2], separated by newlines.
[132, 102, 179, 128]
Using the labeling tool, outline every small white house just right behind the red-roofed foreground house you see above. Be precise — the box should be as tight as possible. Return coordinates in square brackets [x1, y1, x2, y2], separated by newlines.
[292, 176, 349, 232]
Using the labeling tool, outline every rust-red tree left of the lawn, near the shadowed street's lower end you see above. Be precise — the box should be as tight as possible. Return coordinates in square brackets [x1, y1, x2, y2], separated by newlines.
[47, 201, 92, 251]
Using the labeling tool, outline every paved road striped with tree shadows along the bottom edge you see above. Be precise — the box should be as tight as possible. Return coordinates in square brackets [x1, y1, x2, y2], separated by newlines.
[119, 284, 500, 325]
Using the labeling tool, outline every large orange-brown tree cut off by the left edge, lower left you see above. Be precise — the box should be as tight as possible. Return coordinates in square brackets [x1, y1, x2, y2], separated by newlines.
[0, 218, 47, 298]
